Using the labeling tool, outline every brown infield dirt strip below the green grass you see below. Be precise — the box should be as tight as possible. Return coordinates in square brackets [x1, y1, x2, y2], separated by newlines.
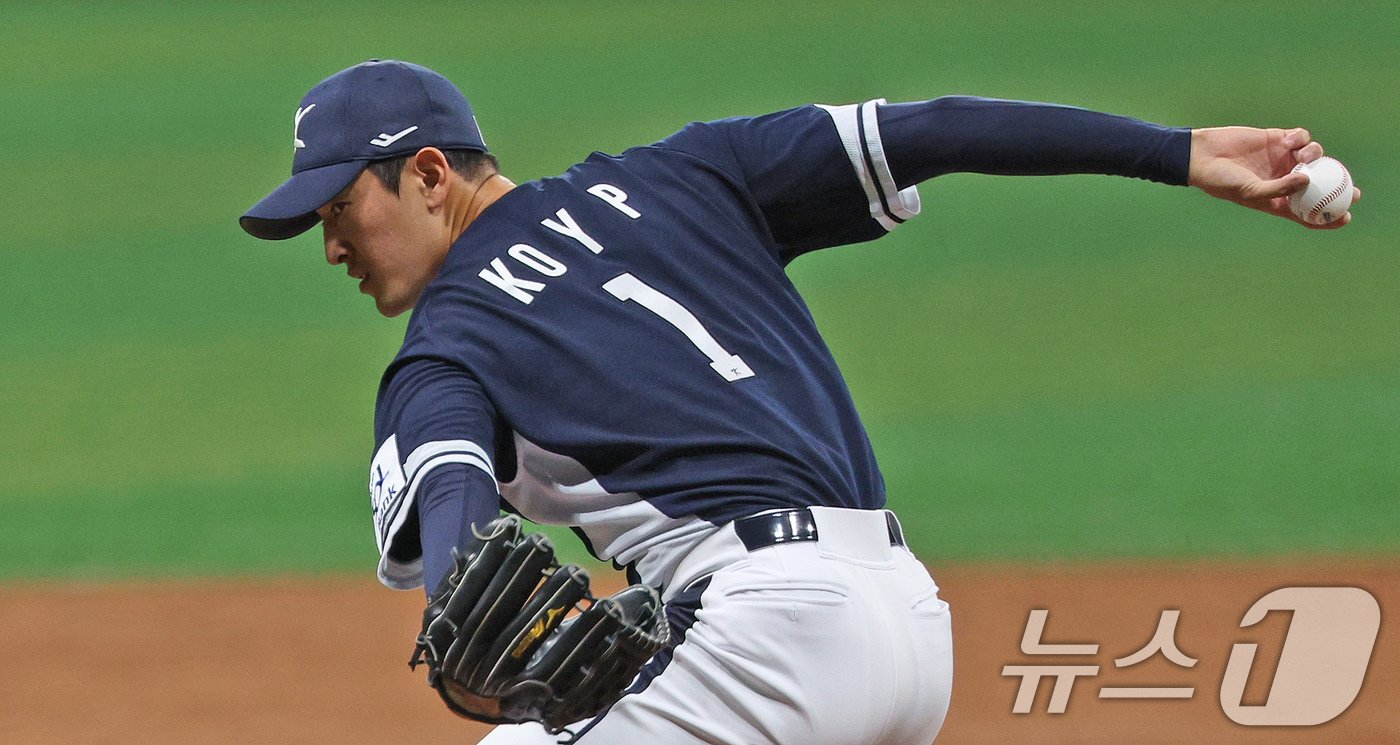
[0, 560, 1400, 745]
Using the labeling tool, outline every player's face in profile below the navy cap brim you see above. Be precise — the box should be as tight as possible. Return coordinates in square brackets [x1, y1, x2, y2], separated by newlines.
[316, 171, 447, 318]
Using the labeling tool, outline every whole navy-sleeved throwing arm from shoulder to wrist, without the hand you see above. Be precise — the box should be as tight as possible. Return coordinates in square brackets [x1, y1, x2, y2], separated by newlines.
[660, 95, 1191, 259]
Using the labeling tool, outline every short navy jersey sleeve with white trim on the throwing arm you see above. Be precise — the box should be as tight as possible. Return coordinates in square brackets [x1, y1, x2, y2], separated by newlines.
[662, 99, 920, 260]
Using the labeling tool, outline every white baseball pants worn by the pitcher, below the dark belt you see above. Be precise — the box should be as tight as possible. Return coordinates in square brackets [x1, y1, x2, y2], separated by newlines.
[482, 507, 953, 745]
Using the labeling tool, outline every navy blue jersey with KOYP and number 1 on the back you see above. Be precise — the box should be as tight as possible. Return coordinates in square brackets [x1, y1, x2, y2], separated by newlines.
[370, 99, 1179, 588]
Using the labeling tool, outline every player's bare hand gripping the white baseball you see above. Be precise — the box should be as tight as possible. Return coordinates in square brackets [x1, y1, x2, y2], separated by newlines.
[1187, 126, 1361, 230]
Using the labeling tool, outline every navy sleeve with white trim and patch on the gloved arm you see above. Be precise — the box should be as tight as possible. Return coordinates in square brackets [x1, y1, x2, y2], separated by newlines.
[370, 357, 500, 590]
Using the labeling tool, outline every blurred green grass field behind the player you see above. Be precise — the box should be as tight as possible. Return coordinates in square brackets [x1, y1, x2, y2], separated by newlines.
[0, 0, 1400, 578]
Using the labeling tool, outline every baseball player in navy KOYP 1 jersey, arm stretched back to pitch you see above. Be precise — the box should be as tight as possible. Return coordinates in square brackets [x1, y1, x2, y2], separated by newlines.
[241, 60, 1359, 745]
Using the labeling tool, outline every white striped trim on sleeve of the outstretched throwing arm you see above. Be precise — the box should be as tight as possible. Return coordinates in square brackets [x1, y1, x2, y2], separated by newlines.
[818, 98, 921, 231]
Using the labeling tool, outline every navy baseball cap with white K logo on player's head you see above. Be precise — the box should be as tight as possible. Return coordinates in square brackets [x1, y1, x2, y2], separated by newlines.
[238, 60, 486, 241]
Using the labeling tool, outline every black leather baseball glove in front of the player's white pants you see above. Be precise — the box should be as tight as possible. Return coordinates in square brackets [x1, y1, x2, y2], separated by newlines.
[409, 517, 669, 734]
